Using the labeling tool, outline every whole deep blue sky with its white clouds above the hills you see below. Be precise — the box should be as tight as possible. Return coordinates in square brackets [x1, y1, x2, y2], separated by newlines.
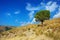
[0, 0, 60, 26]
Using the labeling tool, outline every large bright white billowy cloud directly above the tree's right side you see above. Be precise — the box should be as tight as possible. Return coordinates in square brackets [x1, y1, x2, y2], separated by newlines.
[40, 1, 58, 12]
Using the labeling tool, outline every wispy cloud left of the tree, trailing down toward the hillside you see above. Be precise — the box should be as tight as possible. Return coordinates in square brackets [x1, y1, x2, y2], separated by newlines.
[26, 3, 40, 24]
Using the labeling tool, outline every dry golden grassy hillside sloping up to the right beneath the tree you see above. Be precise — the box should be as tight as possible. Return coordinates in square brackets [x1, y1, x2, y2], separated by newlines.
[0, 18, 60, 40]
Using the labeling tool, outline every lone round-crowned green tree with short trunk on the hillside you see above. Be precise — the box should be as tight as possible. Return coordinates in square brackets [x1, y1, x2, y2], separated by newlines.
[35, 10, 50, 26]
